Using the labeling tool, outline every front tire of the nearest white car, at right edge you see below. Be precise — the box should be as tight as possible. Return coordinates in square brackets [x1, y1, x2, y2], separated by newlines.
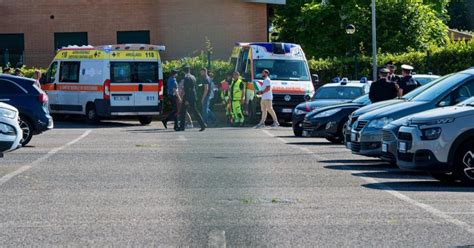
[453, 141, 474, 185]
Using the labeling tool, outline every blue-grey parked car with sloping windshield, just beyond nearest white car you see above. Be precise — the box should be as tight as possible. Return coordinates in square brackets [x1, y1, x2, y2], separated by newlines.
[351, 70, 474, 157]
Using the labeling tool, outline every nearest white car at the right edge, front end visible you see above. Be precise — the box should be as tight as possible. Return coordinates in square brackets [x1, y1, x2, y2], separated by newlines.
[398, 98, 474, 184]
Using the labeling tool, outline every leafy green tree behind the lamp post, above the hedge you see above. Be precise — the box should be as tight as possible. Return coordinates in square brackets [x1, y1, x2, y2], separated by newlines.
[274, 0, 447, 57]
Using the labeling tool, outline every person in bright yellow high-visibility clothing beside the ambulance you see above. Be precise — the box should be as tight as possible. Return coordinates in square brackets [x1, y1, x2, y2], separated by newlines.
[229, 72, 245, 127]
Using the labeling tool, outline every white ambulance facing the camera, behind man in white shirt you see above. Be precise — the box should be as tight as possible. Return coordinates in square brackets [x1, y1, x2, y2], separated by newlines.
[231, 42, 315, 121]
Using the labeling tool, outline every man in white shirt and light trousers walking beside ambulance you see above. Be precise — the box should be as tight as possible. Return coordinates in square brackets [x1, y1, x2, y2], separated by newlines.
[256, 69, 280, 128]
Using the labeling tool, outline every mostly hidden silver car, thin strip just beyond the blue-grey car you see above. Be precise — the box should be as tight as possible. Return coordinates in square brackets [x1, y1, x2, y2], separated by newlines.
[344, 76, 440, 149]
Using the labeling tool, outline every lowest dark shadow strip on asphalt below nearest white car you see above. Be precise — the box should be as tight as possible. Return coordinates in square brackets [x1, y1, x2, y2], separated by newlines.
[362, 179, 474, 192]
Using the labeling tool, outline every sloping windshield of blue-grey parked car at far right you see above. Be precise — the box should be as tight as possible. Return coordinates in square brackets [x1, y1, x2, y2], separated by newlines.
[412, 73, 470, 102]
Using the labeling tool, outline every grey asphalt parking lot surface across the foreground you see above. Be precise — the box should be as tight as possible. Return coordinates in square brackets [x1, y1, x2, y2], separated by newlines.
[0, 122, 474, 247]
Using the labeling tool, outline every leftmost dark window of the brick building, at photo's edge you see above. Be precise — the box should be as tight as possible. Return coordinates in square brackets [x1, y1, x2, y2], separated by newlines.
[0, 34, 25, 67]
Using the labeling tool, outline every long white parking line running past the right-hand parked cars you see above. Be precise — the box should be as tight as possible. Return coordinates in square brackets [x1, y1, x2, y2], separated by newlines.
[262, 130, 474, 234]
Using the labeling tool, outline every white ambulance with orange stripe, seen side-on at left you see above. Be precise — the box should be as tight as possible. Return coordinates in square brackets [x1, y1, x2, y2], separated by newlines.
[41, 44, 165, 125]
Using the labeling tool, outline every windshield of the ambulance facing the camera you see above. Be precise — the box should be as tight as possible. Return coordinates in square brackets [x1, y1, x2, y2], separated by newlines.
[254, 59, 310, 81]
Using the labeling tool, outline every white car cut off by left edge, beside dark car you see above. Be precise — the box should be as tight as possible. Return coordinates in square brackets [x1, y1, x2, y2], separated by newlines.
[0, 103, 23, 157]
